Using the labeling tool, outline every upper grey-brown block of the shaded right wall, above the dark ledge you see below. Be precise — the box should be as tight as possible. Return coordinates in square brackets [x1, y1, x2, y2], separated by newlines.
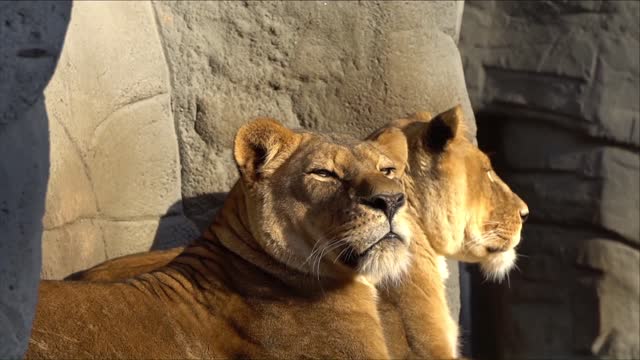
[461, 1, 640, 146]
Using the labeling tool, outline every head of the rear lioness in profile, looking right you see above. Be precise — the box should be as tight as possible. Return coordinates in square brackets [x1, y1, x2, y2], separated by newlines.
[370, 106, 529, 281]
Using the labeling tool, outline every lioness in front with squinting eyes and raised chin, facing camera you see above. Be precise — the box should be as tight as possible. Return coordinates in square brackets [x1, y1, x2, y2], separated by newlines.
[27, 119, 458, 359]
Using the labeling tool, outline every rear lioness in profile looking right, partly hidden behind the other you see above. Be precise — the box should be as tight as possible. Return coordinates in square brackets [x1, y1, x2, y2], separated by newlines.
[70, 106, 528, 358]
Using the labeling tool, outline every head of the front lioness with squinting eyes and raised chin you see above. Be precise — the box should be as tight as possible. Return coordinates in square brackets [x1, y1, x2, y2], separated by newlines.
[234, 119, 411, 282]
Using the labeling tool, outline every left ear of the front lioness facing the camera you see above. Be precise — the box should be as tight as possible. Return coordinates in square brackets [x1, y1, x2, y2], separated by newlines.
[233, 118, 296, 182]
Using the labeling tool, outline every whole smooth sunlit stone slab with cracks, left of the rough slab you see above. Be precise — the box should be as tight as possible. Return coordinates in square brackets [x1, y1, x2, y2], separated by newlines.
[42, 2, 193, 279]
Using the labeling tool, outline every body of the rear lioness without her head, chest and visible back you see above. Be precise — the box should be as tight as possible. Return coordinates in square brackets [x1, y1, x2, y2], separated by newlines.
[68, 240, 457, 359]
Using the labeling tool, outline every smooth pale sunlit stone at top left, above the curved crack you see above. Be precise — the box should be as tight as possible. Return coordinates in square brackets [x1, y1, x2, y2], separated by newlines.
[46, 1, 169, 156]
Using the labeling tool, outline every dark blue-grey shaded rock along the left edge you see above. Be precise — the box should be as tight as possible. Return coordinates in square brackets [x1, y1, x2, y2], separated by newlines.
[0, 2, 71, 359]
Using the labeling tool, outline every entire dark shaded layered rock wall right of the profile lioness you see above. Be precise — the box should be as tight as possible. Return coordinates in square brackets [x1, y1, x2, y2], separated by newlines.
[460, 1, 640, 359]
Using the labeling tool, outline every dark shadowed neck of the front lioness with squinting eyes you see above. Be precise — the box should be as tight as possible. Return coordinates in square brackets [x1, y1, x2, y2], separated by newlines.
[162, 182, 356, 296]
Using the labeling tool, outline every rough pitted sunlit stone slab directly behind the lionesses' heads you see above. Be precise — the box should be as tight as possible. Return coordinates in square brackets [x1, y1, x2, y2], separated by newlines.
[154, 1, 475, 222]
